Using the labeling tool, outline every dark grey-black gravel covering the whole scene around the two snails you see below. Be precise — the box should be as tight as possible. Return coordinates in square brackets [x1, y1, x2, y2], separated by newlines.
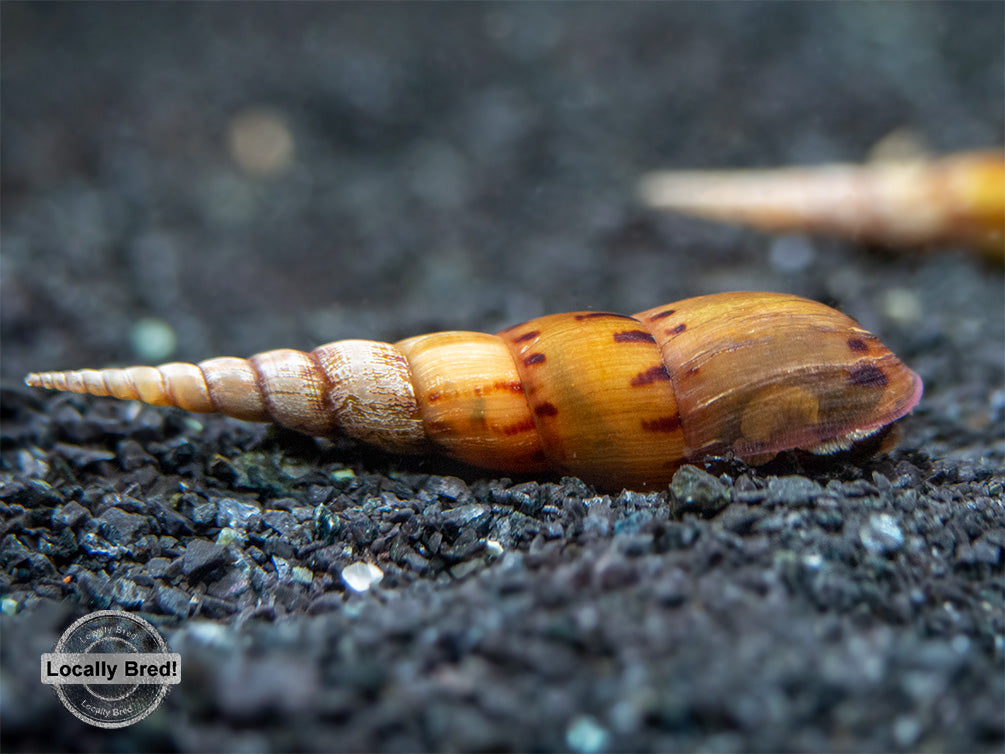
[0, 2, 1005, 754]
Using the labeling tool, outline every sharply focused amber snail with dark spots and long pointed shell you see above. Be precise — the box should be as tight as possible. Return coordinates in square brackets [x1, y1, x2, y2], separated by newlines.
[25, 293, 922, 489]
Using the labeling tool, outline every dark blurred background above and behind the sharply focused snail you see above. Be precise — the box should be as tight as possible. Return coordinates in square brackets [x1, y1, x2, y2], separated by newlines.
[0, 2, 1005, 398]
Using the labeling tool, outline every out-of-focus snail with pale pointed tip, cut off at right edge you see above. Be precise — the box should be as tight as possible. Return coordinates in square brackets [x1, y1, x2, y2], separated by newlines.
[639, 150, 1005, 263]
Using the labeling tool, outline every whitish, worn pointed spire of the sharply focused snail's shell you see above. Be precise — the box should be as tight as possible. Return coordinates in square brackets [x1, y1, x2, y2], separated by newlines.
[25, 341, 427, 452]
